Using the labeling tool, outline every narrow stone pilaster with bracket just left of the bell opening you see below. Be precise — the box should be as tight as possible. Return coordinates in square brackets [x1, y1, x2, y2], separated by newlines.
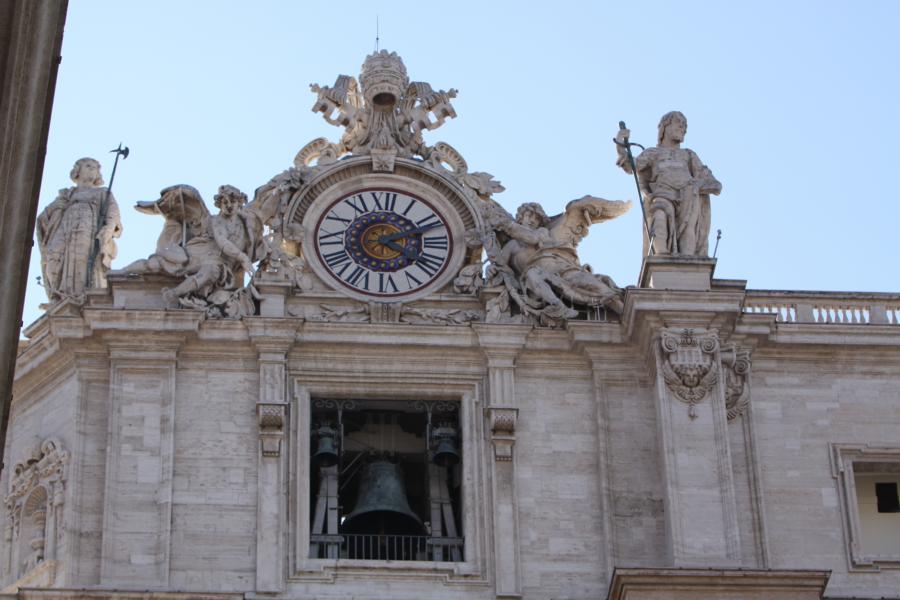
[245, 318, 298, 592]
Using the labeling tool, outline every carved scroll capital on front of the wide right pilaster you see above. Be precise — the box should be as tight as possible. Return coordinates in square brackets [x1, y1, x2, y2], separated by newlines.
[660, 329, 719, 419]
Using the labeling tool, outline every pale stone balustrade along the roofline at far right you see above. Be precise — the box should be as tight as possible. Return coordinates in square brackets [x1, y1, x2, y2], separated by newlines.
[744, 290, 900, 325]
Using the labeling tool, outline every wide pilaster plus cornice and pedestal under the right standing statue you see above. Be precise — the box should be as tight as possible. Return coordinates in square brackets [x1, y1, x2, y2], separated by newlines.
[624, 257, 744, 568]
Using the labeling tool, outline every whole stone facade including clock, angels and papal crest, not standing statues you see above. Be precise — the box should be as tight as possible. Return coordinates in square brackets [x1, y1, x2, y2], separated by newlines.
[0, 52, 900, 600]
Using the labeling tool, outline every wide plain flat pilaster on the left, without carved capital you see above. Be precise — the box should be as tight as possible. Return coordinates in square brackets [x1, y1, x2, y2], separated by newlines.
[100, 332, 184, 589]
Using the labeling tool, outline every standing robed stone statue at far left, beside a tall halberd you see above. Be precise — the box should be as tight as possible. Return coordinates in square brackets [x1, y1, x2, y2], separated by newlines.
[35, 158, 122, 303]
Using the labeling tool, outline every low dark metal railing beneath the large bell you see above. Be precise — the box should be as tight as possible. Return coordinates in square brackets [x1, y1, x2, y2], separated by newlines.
[310, 533, 463, 562]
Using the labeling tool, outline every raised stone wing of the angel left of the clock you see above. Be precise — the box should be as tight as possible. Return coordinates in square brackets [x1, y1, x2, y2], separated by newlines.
[135, 184, 209, 250]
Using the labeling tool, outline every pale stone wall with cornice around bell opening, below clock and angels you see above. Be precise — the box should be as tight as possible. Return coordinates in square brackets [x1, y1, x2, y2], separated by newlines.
[7, 274, 900, 600]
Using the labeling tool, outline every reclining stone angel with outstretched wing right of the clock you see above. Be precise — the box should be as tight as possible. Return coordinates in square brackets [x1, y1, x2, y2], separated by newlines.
[483, 196, 631, 325]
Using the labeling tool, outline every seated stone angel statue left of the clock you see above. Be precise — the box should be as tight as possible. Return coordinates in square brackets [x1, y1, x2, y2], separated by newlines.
[116, 185, 265, 318]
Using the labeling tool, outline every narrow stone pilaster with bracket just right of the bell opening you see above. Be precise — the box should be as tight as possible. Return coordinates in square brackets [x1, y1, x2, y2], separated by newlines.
[473, 325, 531, 599]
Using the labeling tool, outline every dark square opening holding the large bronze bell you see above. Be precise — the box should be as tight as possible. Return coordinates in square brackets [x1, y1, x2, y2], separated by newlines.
[309, 399, 464, 562]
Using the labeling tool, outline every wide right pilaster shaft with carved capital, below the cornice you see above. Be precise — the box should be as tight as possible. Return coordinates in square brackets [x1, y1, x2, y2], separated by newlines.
[652, 326, 740, 567]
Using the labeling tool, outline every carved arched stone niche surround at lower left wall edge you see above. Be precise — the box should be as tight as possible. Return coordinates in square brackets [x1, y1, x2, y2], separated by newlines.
[3, 439, 69, 577]
